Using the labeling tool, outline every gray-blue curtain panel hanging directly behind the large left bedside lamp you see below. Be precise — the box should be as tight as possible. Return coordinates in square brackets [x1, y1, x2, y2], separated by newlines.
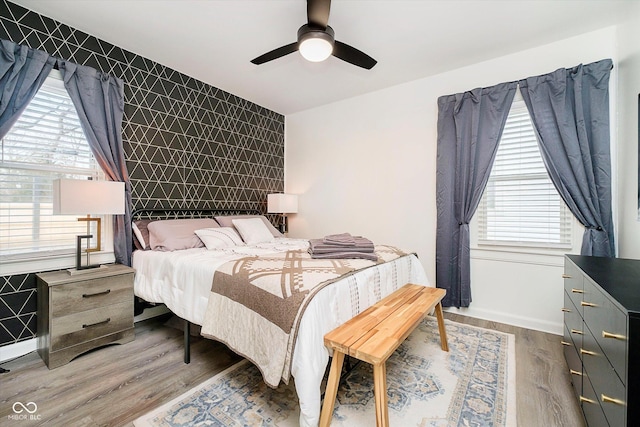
[58, 61, 132, 266]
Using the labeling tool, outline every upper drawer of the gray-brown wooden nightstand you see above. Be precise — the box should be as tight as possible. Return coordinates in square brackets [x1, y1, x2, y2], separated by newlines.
[50, 274, 133, 317]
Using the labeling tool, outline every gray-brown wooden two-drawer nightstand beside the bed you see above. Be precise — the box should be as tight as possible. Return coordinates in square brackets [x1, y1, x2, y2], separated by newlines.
[36, 264, 135, 369]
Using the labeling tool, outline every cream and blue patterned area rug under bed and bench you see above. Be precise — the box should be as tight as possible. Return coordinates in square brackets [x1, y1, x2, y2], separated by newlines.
[134, 317, 516, 427]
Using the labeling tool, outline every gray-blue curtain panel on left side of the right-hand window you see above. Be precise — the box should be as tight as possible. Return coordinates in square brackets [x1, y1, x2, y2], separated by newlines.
[436, 82, 517, 307]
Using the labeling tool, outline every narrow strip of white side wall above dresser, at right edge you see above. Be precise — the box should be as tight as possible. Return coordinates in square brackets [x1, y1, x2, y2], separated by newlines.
[617, 3, 640, 259]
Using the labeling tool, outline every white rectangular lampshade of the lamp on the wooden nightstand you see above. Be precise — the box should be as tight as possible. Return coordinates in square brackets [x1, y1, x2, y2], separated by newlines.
[53, 179, 124, 215]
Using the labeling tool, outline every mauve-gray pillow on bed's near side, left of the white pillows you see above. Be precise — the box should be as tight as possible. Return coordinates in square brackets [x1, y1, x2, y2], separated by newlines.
[147, 218, 218, 252]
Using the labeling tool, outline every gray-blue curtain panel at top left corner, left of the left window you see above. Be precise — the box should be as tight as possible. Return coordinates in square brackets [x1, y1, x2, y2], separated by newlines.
[0, 40, 56, 138]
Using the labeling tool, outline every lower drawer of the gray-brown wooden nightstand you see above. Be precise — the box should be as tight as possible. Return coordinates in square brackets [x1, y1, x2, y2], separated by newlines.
[51, 300, 133, 351]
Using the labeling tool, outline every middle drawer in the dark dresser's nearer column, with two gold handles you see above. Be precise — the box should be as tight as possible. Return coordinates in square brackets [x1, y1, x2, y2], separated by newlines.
[582, 333, 627, 426]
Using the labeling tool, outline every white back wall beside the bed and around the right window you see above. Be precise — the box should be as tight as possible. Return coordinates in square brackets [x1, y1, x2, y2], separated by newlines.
[285, 27, 620, 333]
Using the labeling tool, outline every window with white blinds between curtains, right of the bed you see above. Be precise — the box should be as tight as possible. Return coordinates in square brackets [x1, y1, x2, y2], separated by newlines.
[477, 92, 572, 248]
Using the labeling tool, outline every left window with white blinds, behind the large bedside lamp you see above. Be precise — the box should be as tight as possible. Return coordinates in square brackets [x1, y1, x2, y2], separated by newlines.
[0, 70, 104, 262]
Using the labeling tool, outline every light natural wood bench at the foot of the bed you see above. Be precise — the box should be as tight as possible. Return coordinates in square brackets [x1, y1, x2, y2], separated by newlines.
[320, 284, 449, 427]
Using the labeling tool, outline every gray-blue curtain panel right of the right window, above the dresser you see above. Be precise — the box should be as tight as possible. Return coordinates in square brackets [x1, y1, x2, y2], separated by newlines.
[519, 59, 615, 257]
